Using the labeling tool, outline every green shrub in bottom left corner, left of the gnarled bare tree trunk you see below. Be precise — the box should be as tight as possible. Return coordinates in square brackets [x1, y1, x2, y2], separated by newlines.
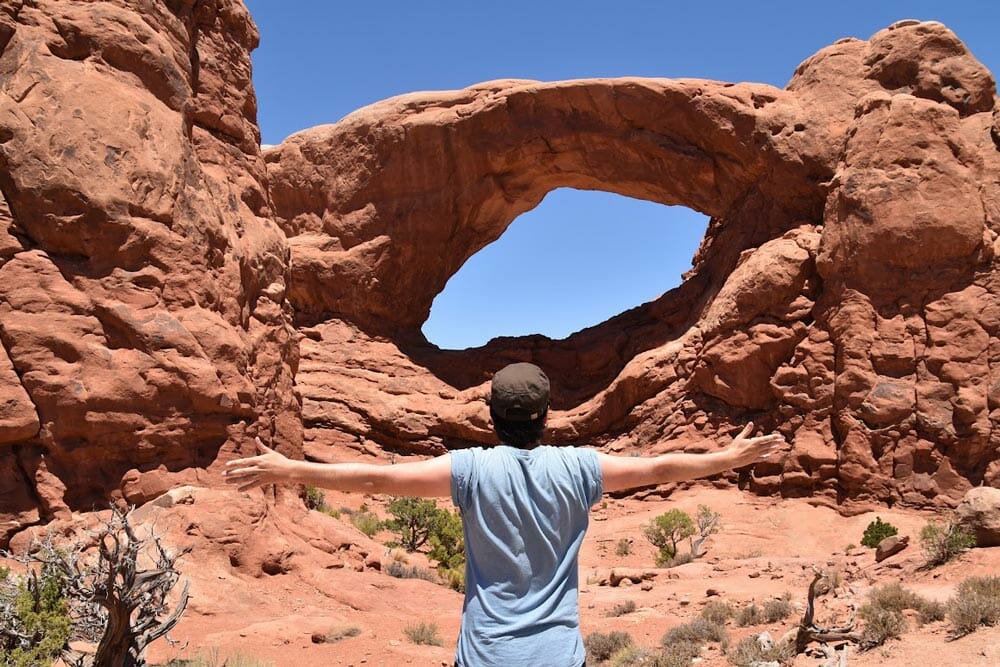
[0, 563, 72, 667]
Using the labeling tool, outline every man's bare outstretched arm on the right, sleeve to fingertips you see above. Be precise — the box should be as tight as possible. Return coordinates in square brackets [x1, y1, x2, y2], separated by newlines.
[597, 423, 785, 492]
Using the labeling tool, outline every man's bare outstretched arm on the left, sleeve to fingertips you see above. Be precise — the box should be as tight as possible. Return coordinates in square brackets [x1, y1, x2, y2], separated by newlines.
[224, 440, 451, 498]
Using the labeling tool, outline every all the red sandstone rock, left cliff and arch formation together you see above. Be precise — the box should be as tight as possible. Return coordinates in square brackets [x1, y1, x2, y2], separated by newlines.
[0, 0, 1000, 543]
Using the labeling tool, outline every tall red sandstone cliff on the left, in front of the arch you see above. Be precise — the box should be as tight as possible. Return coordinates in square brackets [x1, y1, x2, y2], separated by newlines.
[0, 0, 301, 544]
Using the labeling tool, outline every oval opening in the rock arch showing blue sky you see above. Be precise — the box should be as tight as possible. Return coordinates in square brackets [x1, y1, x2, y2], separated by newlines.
[422, 188, 708, 350]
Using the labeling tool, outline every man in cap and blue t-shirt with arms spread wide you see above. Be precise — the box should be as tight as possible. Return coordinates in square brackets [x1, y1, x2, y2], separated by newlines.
[226, 363, 784, 667]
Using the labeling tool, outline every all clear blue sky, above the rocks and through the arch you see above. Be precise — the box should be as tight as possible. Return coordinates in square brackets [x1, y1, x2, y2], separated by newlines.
[247, 0, 1000, 348]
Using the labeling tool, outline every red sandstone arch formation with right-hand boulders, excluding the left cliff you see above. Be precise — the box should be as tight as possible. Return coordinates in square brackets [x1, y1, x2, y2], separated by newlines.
[265, 21, 1000, 506]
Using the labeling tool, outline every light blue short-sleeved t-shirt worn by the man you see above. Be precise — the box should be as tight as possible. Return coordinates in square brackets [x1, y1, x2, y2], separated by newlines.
[451, 446, 603, 667]
